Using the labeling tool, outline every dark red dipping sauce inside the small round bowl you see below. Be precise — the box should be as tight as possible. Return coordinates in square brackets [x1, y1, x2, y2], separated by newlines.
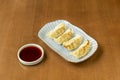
[20, 46, 42, 62]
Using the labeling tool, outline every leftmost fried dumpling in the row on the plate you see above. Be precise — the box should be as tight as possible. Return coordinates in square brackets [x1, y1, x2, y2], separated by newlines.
[47, 23, 66, 39]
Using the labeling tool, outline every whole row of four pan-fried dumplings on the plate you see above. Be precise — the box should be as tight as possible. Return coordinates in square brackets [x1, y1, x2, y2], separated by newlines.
[47, 23, 91, 58]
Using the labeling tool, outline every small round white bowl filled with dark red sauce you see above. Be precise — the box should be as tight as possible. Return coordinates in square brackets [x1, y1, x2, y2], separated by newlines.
[17, 43, 44, 65]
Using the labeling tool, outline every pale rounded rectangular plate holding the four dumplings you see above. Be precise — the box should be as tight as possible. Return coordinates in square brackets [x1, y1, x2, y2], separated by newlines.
[38, 20, 98, 63]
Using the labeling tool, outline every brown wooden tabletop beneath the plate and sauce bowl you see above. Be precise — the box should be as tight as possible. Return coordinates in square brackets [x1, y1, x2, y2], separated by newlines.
[0, 0, 120, 80]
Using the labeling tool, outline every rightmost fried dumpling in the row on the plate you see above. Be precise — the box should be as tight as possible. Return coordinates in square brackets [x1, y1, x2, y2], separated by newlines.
[71, 40, 91, 58]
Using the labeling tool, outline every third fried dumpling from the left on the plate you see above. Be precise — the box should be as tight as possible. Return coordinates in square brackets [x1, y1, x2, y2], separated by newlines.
[63, 35, 83, 50]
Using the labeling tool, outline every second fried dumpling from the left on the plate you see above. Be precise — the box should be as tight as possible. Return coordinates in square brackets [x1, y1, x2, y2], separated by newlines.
[54, 28, 73, 44]
